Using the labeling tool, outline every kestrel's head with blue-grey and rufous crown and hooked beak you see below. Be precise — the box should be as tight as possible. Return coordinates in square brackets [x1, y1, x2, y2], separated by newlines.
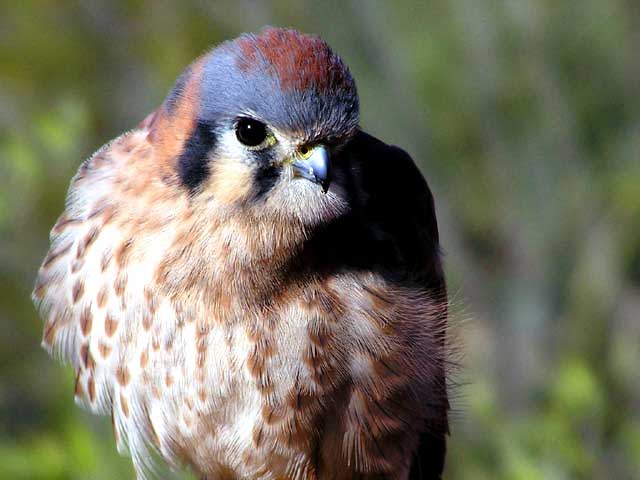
[149, 28, 359, 229]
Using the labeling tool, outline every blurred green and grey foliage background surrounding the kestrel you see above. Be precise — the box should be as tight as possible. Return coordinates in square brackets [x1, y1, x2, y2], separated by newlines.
[0, 0, 640, 480]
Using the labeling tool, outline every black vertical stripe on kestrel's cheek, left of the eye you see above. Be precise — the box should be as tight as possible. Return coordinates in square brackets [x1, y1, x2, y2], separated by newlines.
[178, 122, 217, 193]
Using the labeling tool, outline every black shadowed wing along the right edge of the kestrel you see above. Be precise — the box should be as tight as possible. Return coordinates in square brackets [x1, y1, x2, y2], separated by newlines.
[345, 132, 449, 480]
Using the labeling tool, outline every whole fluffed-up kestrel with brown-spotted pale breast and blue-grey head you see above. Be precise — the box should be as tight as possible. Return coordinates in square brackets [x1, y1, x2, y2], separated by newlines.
[32, 27, 449, 479]
